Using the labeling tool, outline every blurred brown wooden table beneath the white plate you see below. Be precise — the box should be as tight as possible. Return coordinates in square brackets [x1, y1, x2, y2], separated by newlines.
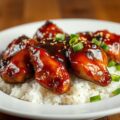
[0, 0, 120, 120]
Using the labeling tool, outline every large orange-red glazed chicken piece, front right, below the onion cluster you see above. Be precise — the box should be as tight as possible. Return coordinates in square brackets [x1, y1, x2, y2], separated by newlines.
[68, 42, 111, 86]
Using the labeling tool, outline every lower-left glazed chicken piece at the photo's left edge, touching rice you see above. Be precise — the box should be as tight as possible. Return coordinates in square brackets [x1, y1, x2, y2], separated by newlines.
[0, 49, 32, 83]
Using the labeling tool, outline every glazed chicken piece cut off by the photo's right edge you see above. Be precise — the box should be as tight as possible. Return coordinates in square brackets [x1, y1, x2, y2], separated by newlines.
[94, 30, 120, 63]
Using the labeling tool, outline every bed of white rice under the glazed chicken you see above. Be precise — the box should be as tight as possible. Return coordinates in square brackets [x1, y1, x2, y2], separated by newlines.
[0, 67, 120, 104]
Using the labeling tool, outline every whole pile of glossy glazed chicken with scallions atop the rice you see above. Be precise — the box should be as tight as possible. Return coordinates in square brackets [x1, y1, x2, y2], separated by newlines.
[0, 21, 120, 94]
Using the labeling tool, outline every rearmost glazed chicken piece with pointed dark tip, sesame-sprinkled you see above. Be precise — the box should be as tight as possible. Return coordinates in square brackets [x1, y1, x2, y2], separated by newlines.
[34, 21, 69, 66]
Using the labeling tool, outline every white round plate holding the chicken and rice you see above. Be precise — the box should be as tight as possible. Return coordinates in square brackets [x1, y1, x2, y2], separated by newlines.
[0, 19, 120, 120]
